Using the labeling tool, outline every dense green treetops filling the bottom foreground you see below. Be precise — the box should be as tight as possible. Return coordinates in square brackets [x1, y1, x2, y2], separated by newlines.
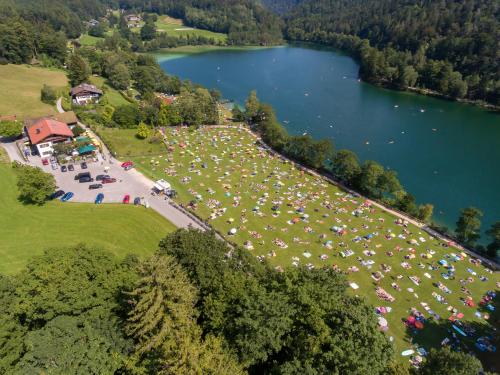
[0, 230, 481, 375]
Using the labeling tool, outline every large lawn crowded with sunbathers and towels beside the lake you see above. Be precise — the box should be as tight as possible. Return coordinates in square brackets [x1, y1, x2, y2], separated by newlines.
[99, 128, 500, 362]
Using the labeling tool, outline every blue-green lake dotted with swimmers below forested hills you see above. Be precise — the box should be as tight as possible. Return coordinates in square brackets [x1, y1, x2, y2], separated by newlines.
[158, 46, 500, 238]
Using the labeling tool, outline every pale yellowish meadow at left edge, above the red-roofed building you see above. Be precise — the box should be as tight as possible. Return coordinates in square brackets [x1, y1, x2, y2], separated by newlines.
[0, 64, 67, 119]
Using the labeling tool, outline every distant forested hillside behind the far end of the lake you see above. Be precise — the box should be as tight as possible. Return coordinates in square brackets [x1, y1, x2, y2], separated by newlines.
[115, 0, 283, 45]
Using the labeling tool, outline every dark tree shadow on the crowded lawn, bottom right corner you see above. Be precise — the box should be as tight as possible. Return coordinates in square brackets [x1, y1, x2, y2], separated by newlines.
[401, 290, 500, 372]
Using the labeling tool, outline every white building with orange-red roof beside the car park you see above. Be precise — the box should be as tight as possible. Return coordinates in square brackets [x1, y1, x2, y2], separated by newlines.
[26, 118, 73, 157]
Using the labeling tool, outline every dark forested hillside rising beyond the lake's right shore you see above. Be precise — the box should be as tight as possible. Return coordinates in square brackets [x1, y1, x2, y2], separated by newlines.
[284, 0, 500, 105]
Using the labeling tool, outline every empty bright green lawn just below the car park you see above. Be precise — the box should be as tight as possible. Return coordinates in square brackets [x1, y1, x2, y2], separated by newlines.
[0, 148, 175, 274]
